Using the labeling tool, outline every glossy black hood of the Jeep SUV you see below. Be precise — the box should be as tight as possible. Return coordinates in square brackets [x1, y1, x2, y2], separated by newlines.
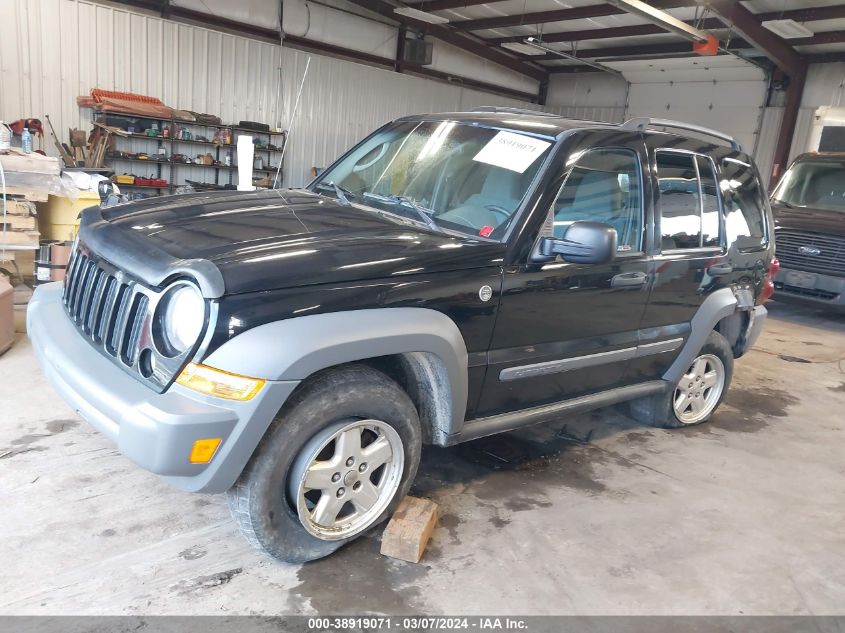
[94, 190, 505, 294]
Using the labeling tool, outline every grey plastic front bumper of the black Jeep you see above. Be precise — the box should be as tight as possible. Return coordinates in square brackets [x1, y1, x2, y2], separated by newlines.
[27, 283, 298, 492]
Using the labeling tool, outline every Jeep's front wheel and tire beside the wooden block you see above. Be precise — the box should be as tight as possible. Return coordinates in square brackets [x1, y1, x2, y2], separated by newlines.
[228, 365, 422, 563]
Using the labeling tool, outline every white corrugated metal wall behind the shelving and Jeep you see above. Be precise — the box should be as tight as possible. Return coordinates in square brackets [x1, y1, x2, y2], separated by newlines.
[0, 0, 548, 186]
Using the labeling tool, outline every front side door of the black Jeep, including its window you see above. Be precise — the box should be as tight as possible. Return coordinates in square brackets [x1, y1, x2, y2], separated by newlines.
[477, 144, 649, 416]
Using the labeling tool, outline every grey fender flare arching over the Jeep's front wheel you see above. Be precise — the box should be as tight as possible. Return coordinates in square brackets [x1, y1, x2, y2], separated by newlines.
[202, 308, 468, 441]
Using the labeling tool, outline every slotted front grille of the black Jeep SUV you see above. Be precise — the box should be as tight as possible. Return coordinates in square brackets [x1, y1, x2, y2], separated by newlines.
[63, 250, 149, 368]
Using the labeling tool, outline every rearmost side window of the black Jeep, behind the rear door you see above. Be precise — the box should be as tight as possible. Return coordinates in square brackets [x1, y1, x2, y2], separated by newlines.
[719, 159, 767, 246]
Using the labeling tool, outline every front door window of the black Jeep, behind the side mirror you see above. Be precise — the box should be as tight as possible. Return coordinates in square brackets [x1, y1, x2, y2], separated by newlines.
[554, 149, 643, 252]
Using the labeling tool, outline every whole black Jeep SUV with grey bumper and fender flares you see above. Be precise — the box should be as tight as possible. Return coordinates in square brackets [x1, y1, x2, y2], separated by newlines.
[28, 109, 774, 561]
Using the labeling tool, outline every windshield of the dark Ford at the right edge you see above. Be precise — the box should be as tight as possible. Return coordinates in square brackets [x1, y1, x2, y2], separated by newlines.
[774, 159, 845, 212]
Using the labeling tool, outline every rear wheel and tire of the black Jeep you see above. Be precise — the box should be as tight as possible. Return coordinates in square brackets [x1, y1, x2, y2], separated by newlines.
[628, 331, 734, 429]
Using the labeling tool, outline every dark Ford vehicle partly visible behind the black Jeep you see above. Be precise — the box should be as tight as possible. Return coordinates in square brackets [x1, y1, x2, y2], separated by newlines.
[772, 152, 845, 311]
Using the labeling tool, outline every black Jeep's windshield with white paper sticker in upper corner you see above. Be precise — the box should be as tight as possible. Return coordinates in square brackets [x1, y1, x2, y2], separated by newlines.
[310, 121, 552, 239]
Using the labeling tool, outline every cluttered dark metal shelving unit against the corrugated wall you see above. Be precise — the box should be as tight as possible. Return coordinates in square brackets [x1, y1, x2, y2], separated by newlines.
[94, 110, 287, 193]
